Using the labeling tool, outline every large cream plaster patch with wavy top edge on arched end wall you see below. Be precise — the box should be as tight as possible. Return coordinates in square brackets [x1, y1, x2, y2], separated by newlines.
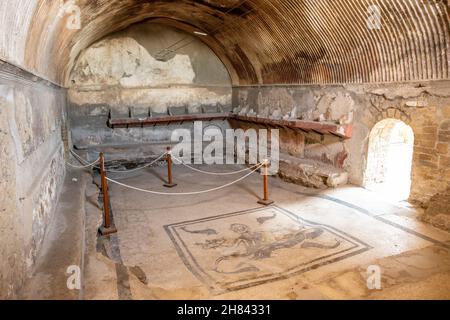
[72, 37, 195, 88]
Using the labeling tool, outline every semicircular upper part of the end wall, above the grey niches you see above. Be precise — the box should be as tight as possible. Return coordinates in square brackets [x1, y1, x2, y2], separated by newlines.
[68, 25, 232, 113]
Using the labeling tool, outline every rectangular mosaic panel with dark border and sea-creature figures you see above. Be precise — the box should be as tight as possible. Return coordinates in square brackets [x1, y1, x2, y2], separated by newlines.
[165, 206, 370, 292]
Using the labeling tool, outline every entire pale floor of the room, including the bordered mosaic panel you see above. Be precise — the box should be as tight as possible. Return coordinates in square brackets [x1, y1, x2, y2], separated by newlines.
[75, 167, 450, 300]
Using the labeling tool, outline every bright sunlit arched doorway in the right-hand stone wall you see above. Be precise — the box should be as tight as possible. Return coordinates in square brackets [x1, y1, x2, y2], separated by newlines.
[364, 119, 414, 201]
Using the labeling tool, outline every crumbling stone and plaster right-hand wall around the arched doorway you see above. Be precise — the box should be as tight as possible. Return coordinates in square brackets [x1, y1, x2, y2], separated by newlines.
[233, 81, 450, 204]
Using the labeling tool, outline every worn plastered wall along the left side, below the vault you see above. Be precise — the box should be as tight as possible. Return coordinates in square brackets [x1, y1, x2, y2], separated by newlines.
[0, 63, 66, 298]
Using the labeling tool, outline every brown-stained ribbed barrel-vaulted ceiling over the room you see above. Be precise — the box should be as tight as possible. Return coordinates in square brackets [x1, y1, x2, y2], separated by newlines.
[0, 0, 449, 85]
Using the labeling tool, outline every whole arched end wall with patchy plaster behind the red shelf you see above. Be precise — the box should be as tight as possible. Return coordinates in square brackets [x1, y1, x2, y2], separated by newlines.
[69, 22, 232, 150]
